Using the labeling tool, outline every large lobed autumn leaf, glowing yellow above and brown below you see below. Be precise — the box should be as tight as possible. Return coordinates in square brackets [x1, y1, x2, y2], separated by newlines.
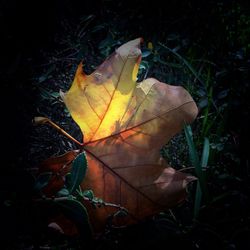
[61, 39, 197, 231]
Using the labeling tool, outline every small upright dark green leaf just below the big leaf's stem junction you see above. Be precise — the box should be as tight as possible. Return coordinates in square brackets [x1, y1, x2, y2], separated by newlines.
[68, 152, 88, 193]
